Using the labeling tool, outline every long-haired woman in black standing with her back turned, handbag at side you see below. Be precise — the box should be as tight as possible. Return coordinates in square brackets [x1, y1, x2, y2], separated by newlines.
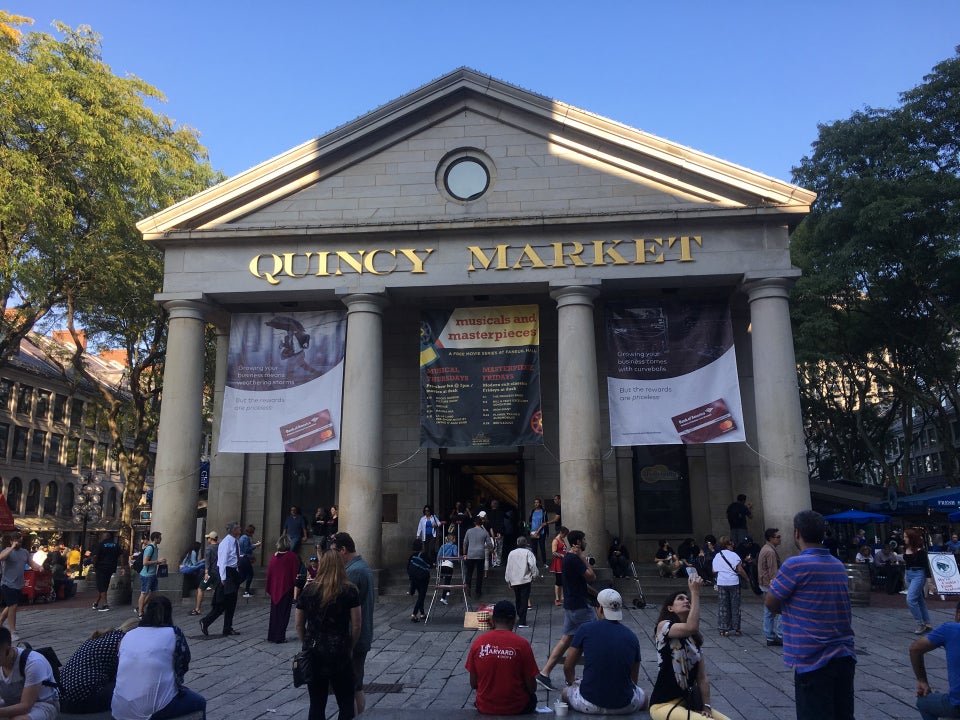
[297, 552, 360, 720]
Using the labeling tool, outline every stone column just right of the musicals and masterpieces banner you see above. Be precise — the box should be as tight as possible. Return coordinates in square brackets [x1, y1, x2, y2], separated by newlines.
[550, 284, 607, 565]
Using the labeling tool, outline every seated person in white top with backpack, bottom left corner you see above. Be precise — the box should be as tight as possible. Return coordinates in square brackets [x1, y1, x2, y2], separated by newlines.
[0, 627, 60, 720]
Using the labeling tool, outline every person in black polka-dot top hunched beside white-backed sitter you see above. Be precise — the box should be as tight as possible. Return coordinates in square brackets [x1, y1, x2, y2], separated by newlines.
[60, 618, 139, 714]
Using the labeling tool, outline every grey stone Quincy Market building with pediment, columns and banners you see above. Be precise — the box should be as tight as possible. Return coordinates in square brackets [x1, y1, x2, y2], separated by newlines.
[139, 69, 815, 568]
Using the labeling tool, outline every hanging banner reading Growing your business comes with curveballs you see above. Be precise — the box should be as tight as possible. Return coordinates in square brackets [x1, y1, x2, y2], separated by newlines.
[606, 298, 746, 446]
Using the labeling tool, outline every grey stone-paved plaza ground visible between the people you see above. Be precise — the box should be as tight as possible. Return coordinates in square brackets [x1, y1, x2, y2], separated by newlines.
[18, 588, 954, 720]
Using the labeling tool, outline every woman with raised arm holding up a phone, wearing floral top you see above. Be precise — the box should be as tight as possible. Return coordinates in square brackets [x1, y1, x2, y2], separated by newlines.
[650, 577, 727, 720]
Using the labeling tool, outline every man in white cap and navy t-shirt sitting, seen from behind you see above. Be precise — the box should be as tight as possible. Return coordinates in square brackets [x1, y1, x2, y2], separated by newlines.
[560, 589, 647, 715]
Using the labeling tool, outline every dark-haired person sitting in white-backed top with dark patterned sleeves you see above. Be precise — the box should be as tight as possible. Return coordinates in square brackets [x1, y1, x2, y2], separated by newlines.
[110, 595, 207, 720]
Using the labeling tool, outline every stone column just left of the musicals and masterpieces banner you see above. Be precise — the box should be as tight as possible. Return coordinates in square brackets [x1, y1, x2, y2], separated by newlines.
[339, 294, 386, 568]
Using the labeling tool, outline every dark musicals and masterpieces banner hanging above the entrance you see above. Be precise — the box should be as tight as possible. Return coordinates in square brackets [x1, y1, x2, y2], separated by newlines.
[420, 305, 543, 447]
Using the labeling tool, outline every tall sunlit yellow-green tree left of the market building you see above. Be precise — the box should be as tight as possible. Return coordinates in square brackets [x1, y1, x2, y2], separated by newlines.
[0, 14, 217, 544]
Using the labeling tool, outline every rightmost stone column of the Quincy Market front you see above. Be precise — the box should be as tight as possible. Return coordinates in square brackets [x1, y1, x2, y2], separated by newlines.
[744, 277, 810, 546]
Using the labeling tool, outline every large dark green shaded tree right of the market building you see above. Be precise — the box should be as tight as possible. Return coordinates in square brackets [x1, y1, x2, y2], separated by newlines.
[792, 48, 960, 490]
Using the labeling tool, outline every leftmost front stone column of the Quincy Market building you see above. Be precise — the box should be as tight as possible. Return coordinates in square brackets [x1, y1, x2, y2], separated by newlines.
[150, 300, 209, 571]
